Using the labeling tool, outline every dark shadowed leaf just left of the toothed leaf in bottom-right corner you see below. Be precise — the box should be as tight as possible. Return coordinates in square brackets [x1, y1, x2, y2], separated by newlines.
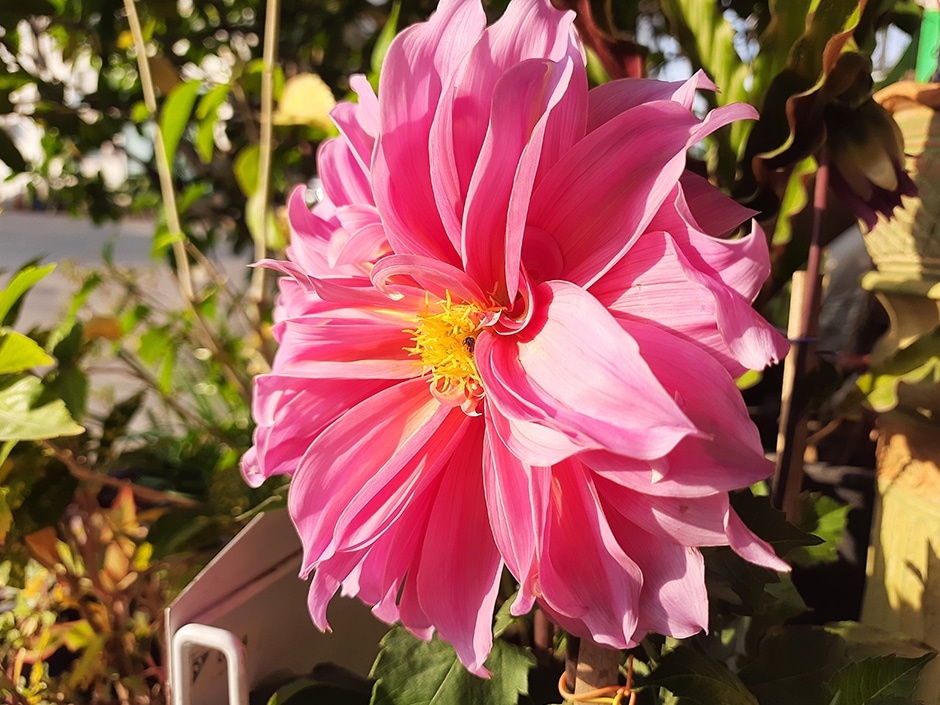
[740, 625, 846, 705]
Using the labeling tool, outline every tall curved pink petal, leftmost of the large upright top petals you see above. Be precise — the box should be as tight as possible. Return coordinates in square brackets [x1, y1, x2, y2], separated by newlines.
[372, 0, 486, 264]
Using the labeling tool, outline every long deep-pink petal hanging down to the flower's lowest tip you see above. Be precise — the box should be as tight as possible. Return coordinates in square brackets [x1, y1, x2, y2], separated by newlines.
[414, 420, 503, 677]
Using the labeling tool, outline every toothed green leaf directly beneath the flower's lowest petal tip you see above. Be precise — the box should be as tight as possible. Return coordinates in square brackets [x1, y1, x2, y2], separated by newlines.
[371, 627, 535, 705]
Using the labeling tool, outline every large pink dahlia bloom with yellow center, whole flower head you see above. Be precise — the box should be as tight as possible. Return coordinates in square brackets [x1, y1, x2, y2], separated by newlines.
[243, 0, 787, 675]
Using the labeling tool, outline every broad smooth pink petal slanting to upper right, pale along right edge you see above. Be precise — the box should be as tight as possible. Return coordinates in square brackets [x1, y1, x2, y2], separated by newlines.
[529, 101, 699, 286]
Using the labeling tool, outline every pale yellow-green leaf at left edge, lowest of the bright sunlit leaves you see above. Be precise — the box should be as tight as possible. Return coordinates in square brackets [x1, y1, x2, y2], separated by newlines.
[0, 377, 85, 441]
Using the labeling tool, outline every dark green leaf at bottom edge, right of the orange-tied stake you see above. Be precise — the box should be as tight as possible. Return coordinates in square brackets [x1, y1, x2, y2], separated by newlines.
[642, 646, 759, 705]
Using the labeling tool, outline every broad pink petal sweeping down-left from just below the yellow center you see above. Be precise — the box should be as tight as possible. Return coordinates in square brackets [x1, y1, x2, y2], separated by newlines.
[288, 379, 450, 571]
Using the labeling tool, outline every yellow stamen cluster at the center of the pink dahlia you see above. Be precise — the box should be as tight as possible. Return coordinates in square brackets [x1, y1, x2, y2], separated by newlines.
[405, 293, 483, 397]
